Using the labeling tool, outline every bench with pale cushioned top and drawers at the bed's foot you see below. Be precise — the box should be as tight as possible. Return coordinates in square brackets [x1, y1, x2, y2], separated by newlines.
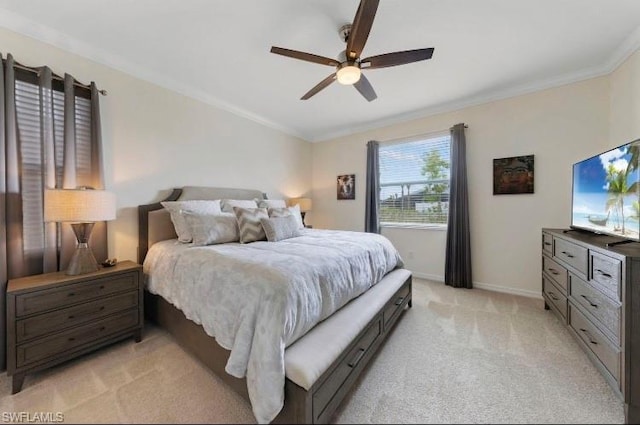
[277, 269, 411, 423]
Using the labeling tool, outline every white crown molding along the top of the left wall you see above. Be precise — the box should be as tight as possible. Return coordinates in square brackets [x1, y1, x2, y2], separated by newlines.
[0, 8, 306, 140]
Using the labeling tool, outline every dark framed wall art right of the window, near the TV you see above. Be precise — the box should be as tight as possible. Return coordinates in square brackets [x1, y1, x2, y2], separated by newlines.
[493, 155, 533, 195]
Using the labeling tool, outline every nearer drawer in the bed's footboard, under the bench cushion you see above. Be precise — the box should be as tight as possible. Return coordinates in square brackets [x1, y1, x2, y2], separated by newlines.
[313, 316, 382, 423]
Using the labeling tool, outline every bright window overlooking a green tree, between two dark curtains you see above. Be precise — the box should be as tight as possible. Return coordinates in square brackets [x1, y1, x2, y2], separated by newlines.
[379, 133, 451, 226]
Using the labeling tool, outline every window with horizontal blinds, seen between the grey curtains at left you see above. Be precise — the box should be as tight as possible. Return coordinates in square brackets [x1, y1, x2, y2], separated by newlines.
[16, 70, 91, 253]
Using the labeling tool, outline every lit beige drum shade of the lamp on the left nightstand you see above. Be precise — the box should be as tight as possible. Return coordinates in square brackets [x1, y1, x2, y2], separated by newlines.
[44, 189, 116, 223]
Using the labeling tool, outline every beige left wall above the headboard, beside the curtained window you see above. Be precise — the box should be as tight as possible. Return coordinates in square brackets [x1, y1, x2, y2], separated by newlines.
[0, 29, 311, 260]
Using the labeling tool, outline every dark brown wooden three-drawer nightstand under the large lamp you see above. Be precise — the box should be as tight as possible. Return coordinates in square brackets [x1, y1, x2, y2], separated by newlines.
[7, 261, 144, 394]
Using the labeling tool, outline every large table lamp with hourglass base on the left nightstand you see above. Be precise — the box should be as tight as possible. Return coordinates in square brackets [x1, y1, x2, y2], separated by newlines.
[44, 188, 116, 276]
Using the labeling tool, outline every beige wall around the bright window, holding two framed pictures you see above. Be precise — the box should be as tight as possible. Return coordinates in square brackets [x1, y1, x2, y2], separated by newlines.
[307, 77, 609, 297]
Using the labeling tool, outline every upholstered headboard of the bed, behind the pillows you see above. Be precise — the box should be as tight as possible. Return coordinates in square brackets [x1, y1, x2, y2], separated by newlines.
[138, 186, 266, 264]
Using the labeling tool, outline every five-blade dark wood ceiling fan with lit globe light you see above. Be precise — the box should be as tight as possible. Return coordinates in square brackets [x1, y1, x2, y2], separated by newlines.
[271, 0, 434, 102]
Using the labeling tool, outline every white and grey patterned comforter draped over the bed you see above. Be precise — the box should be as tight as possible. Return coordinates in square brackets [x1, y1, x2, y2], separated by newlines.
[144, 229, 402, 423]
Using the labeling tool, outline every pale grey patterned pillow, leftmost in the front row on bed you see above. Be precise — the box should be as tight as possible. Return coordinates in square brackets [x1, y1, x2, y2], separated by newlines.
[183, 211, 240, 246]
